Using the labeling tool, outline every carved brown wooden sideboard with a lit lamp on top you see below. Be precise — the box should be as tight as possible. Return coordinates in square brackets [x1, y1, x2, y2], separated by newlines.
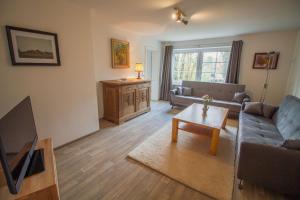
[101, 78, 151, 124]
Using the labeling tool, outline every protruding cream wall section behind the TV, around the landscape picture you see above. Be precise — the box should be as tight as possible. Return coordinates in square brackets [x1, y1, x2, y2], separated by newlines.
[0, 0, 99, 146]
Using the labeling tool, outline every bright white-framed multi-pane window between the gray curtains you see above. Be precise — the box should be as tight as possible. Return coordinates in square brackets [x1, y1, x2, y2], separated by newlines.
[172, 47, 231, 84]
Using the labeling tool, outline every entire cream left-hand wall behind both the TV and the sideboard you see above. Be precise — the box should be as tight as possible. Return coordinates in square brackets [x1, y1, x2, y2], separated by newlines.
[0, 0, 160, 147]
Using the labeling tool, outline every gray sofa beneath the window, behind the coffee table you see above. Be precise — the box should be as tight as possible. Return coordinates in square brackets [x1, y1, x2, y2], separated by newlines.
[170, 81, 250, 118]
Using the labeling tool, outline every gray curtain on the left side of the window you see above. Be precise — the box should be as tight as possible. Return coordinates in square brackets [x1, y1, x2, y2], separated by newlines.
[159, 46, 173, 101]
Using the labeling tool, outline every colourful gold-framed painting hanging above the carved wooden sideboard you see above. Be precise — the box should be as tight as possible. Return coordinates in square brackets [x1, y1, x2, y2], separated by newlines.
[111, 39, 129, 68]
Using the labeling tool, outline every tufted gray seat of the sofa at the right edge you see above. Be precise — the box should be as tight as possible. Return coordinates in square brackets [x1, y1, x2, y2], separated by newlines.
[239, 112, 284, 146]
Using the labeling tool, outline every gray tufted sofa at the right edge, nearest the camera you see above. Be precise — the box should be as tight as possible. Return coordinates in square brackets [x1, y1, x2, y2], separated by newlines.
[237, 96, 300, 198]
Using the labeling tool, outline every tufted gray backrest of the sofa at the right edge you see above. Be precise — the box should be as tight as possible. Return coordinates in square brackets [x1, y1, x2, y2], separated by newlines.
[273, 96, 300, 140]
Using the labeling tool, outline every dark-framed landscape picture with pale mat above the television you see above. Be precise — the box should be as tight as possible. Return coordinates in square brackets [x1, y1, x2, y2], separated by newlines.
[6, 26, 60, 66]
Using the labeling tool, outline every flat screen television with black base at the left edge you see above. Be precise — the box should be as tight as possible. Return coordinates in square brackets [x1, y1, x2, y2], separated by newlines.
[0, 97, 44, 194]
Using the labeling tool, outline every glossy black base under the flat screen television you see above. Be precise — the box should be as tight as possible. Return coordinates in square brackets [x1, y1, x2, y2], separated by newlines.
[25, 149, 45, 177]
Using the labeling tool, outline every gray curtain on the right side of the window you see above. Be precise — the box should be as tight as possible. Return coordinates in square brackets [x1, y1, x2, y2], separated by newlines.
[226, 40, 243, 83]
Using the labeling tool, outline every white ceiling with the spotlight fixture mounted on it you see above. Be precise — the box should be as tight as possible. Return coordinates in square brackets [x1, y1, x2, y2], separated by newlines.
[69, 0, 300, 41]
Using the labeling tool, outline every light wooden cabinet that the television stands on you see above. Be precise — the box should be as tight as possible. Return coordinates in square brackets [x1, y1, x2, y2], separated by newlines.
[0, 138, 60, 200]
